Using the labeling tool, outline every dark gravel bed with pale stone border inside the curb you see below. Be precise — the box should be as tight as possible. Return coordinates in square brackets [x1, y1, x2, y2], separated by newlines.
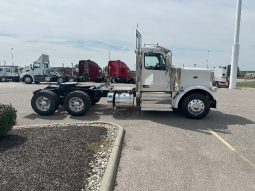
[0, 122, 118, 191]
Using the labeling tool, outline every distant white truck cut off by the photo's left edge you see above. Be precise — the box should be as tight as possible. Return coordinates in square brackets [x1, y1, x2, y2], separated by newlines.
[0, 66, 19, 82]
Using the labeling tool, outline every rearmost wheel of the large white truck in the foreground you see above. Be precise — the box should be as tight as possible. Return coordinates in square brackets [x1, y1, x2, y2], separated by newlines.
[31, 90, 59, 115]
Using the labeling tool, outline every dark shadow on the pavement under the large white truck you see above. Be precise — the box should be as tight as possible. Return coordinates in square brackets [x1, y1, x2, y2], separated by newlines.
[22, 104, 255, 135]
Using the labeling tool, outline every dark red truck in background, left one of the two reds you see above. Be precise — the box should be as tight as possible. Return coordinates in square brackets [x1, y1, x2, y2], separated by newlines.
[78, 60, 103, 82]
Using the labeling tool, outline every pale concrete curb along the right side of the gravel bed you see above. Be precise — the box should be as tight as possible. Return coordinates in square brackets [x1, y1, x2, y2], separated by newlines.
[99, 123, 125, 191]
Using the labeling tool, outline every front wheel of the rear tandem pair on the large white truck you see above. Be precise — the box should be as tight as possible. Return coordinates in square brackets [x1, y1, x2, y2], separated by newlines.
[64, 91, 91, 116]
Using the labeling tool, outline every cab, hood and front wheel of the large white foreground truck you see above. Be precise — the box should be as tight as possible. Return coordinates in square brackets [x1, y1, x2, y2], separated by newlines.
[135, 31, 216, 119]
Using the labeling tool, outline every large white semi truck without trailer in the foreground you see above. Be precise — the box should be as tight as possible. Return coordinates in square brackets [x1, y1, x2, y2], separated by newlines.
[31, 31, 216, 119]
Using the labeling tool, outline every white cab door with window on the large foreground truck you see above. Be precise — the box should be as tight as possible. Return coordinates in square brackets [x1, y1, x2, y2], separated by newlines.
[142, 53, 170, 92]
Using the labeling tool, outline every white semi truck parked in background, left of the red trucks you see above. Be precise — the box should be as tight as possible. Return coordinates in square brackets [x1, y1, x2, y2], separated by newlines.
[20, 54, 63, 84]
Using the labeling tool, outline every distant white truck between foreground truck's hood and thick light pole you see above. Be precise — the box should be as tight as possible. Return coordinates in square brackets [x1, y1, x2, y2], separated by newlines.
[213, 67, 229, 87]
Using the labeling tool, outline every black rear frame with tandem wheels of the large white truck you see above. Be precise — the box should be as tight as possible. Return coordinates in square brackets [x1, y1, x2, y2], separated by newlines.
[31, 82, 136, 116]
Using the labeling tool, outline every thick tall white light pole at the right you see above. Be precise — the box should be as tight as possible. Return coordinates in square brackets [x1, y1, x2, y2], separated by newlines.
[229, 0, 242, 89]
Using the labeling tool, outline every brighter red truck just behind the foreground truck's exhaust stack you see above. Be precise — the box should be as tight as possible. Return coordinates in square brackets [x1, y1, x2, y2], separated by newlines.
[108, 60, 135, 83]
